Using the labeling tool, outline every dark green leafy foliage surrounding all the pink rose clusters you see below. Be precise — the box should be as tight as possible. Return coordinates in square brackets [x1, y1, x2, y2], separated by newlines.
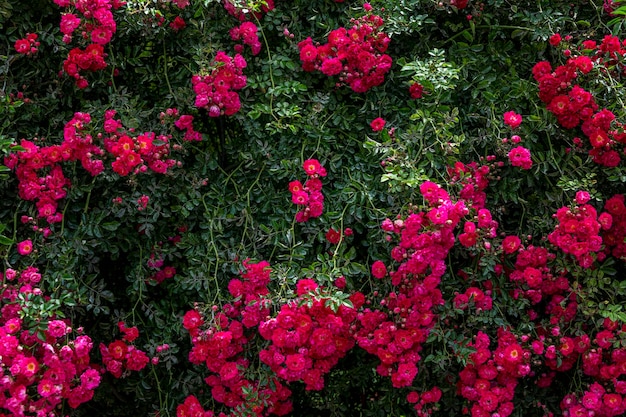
[0, 0, 626, 416]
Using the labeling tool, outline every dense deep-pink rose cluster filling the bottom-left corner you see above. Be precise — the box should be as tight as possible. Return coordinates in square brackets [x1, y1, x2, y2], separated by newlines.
[0, 266, 100, 417]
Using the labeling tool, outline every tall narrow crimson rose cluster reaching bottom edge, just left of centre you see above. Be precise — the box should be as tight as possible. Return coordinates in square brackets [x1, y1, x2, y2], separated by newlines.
[177, 260, 292, 417]
